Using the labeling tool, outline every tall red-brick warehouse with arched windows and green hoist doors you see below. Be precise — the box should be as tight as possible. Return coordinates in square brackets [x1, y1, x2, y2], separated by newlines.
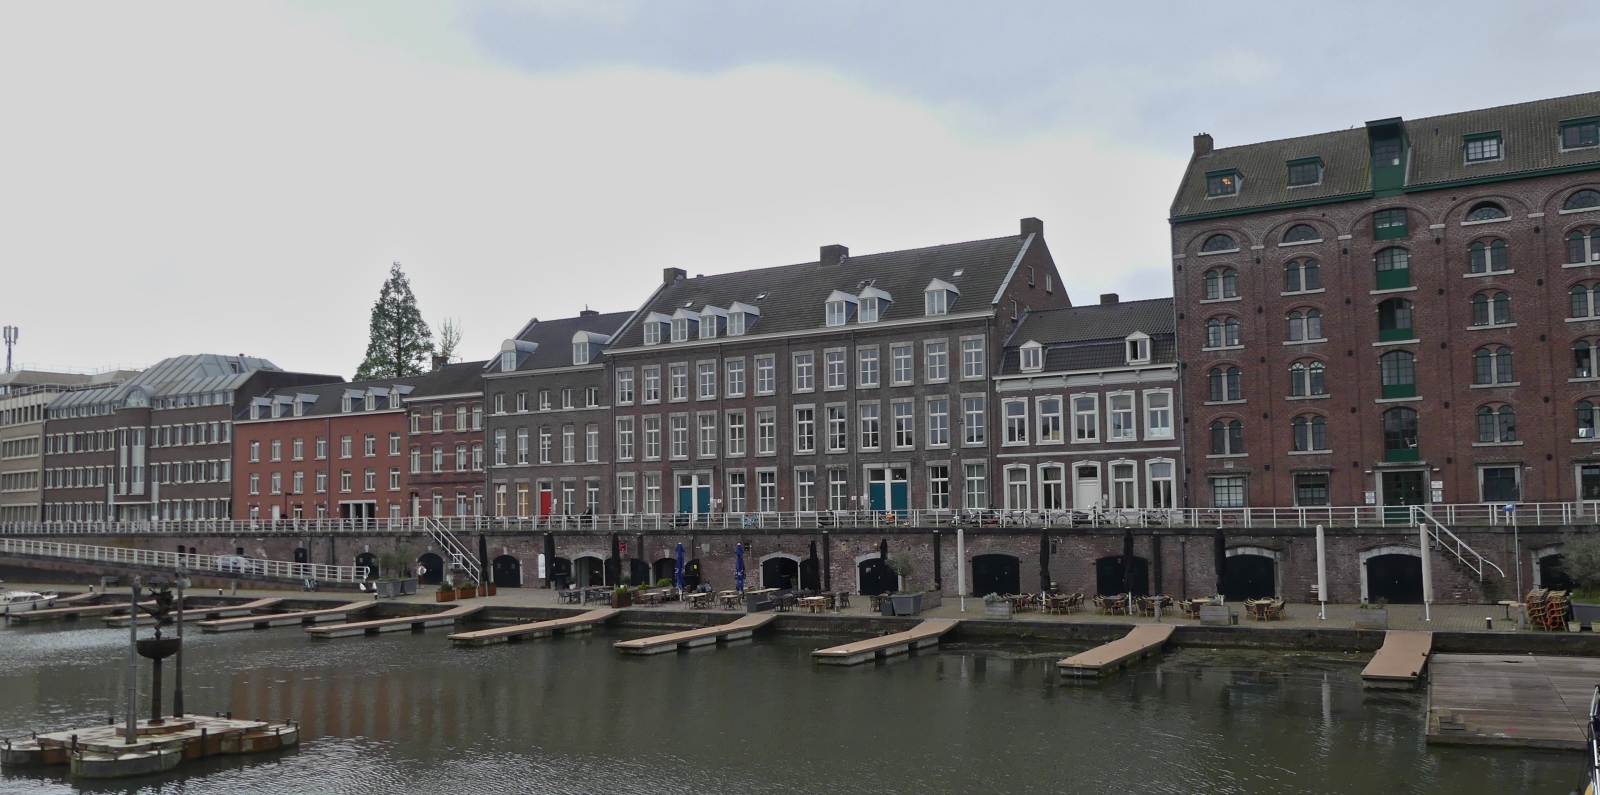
[1171, 94, 1600, 507]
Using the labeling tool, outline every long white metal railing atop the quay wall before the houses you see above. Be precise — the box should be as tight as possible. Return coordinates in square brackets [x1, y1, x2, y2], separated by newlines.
[0, 501, 1600, 534]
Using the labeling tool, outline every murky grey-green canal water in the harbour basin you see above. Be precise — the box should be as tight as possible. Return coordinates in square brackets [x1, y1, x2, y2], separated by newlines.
[0, 625, 1582, 795]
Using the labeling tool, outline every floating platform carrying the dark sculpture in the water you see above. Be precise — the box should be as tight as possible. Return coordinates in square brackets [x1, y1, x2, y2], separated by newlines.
[0, 715, 299, 779]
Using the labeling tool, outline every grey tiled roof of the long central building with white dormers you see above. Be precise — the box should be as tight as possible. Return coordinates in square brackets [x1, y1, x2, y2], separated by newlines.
[613, 235, 1026, 347]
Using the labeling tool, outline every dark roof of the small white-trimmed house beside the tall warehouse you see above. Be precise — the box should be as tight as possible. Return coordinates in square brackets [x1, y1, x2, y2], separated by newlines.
[1000, 298, 1178, 376]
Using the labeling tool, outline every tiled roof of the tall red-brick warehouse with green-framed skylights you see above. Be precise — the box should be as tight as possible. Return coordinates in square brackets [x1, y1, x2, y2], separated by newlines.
[1171, 93, 1600, 219]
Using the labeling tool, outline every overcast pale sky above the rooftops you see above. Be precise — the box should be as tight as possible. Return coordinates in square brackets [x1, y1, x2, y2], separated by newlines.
[0, 0, 1600, 376]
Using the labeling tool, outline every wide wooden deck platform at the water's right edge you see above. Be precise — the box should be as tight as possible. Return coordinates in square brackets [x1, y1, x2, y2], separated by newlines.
[1427, 654, 1600, 750]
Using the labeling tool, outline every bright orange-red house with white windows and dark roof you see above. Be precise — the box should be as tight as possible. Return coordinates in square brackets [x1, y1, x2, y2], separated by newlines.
[232, 376, 427, 521]
